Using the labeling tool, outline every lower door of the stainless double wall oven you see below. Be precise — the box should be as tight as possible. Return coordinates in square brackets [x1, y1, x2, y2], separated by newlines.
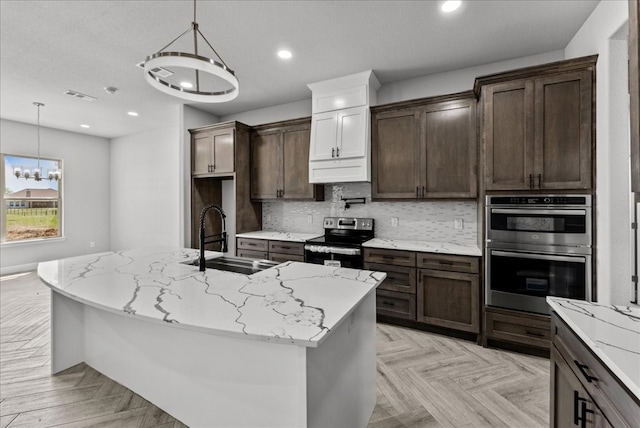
[486, 244, 591, 314]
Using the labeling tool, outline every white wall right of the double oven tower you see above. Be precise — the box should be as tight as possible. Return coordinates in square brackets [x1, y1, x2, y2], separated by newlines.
[565, 1, 631, 304]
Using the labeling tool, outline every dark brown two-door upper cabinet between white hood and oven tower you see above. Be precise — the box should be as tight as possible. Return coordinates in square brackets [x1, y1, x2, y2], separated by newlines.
[371, 92, 477, 200]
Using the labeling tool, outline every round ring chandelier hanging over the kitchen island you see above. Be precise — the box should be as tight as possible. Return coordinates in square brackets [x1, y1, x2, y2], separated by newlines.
[144, 0, 239, 103]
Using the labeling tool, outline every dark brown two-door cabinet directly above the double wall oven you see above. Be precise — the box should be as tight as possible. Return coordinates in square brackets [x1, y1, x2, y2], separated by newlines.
[476, 56, 597, 191]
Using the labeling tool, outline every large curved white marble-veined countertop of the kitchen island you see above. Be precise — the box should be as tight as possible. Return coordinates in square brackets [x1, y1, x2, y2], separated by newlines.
[38, 247, 386, 347]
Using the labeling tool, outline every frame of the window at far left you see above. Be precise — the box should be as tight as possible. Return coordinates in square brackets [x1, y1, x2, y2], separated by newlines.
[0, 152, 65, 247]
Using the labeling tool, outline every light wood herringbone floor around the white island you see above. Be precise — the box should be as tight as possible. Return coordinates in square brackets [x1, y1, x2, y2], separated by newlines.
[0, 272, 549, 428]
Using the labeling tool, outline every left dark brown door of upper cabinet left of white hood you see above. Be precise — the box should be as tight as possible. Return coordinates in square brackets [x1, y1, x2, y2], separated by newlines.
[251, 132, 282, 199]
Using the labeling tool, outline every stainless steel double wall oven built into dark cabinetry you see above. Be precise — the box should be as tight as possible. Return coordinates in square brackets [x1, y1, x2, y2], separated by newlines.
[485, 195, 592, 313]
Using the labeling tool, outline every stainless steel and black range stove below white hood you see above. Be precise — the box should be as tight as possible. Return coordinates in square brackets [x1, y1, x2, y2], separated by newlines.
[304, 217, 374, 269]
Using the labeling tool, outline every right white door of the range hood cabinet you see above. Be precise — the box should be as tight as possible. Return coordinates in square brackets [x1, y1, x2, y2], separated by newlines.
[336, 107, 369, 159]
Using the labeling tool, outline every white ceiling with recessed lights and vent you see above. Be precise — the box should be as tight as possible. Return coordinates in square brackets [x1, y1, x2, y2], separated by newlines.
[0, 0, 598, 138]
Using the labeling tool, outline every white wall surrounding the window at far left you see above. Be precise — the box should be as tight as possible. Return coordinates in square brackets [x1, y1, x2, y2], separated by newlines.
[0, 119, 110, 275]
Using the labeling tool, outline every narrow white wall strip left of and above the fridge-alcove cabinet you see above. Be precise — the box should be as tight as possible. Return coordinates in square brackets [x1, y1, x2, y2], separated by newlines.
[178, 106, 220, 247]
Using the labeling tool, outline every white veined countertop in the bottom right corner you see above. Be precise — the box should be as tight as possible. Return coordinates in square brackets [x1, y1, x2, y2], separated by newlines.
[547, 297, 640, 399]
